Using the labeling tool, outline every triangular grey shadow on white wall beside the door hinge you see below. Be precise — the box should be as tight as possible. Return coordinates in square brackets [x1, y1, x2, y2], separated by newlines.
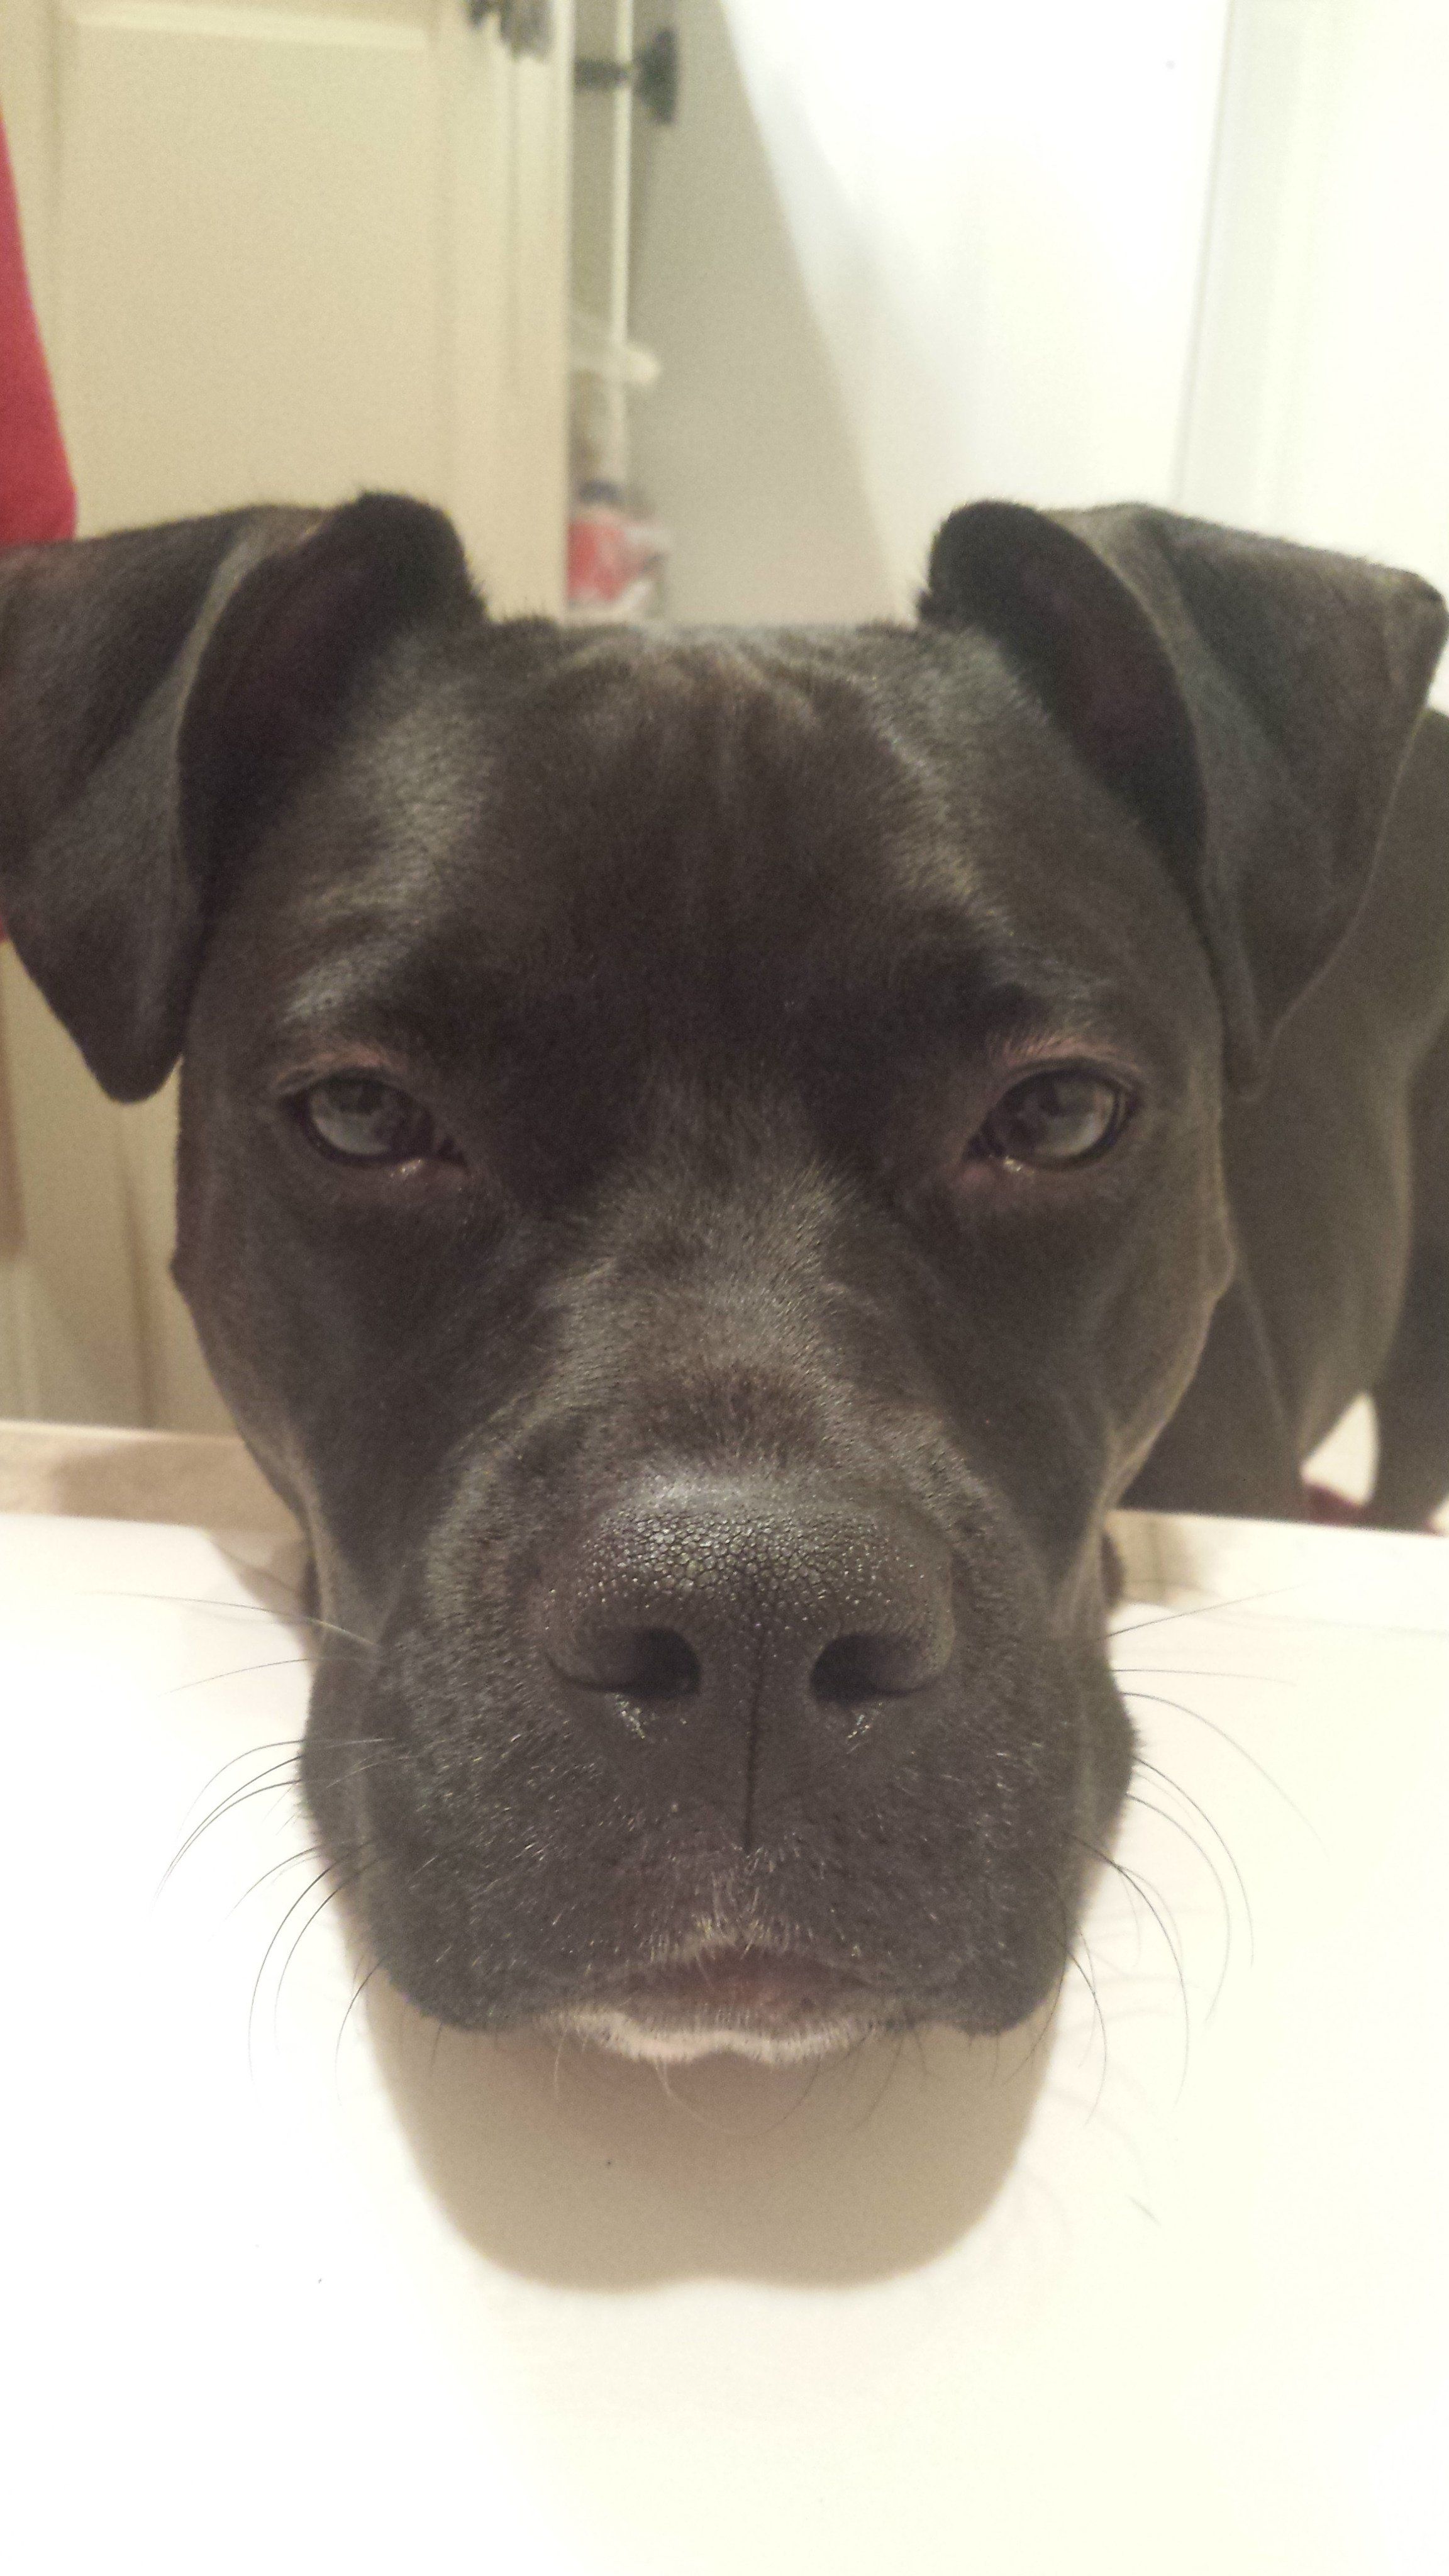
[635, 0, 905, 623]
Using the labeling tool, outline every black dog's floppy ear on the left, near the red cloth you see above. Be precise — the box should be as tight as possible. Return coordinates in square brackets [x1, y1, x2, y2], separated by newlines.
[0, 492, 482, 1100]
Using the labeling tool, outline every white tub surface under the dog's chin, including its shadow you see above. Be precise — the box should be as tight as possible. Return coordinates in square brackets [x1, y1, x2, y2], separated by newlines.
[0, 1514, 1449, 2576]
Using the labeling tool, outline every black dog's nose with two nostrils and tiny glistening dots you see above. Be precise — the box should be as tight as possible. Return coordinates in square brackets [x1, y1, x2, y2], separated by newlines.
[536, 1479, 954, 1823]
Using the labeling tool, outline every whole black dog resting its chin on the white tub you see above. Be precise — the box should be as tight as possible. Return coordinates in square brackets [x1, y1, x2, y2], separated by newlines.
[0, 497, 1449, 2056]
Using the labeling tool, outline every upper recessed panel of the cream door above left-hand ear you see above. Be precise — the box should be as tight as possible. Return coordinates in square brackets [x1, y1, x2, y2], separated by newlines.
[57, 0, 446, 526]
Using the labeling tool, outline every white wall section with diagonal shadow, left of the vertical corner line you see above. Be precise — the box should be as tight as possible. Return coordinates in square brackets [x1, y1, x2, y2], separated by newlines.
[635, 0, 1224, 618]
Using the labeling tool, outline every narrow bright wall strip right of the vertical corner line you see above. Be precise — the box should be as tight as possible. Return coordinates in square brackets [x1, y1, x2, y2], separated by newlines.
[1184, 0, 1449, 703]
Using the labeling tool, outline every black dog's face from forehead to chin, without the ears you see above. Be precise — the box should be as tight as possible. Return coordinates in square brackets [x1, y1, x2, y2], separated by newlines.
[180, 613, 1224, 2045]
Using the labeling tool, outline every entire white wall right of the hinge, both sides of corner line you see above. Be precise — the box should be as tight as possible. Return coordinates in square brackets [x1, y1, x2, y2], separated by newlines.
[635, 0, 1449, 664]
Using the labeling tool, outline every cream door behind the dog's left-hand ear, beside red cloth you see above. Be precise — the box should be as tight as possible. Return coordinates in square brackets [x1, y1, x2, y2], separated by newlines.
[0, 0, 572, 1430]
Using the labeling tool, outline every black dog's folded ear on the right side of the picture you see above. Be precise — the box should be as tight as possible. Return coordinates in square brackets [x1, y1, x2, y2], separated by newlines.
[921, 502, 1449, 1084]
